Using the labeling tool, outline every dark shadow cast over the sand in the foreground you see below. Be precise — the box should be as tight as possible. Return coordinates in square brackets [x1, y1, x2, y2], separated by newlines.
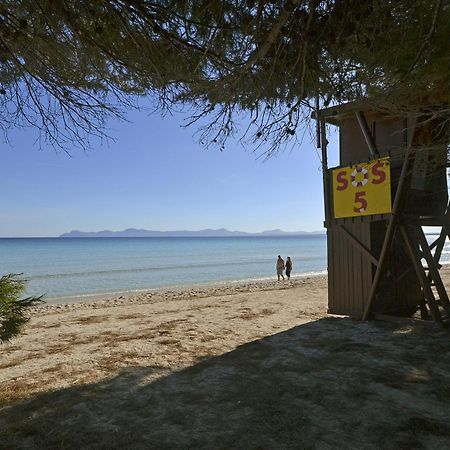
[0, 318, 450, 449]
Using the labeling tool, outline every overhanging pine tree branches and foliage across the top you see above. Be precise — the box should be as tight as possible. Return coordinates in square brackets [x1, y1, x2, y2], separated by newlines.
[0, 0, 450, 151]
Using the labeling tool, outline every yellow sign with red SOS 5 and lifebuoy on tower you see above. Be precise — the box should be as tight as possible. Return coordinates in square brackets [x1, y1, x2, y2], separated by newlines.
[332, 158, 391, 219]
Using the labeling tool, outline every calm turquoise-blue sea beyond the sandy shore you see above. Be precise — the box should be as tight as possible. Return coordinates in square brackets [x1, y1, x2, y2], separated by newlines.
[0, 234, 450, 302]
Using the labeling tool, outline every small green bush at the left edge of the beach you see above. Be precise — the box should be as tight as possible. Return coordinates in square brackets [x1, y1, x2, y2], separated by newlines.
[0, 273, 42, 343]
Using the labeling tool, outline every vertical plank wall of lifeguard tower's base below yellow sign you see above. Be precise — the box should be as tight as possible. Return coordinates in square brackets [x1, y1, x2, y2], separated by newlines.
[327, 217, 372, 318]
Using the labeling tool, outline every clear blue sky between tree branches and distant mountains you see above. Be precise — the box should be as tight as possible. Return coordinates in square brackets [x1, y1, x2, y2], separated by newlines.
[0, 108, 336, 237]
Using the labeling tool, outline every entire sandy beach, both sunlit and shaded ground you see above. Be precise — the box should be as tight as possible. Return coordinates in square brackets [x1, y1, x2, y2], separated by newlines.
[0, 269, 450, 449]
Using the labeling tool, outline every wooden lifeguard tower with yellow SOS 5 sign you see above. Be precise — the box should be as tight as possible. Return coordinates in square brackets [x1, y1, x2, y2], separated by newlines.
[314, 103, 450, 325]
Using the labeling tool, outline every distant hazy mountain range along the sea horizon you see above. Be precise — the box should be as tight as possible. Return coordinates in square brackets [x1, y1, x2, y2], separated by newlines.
[59, 228, 325, 238]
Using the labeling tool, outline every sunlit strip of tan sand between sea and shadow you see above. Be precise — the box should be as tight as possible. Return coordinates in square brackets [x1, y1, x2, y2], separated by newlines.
[0, 277, 326, 399]
